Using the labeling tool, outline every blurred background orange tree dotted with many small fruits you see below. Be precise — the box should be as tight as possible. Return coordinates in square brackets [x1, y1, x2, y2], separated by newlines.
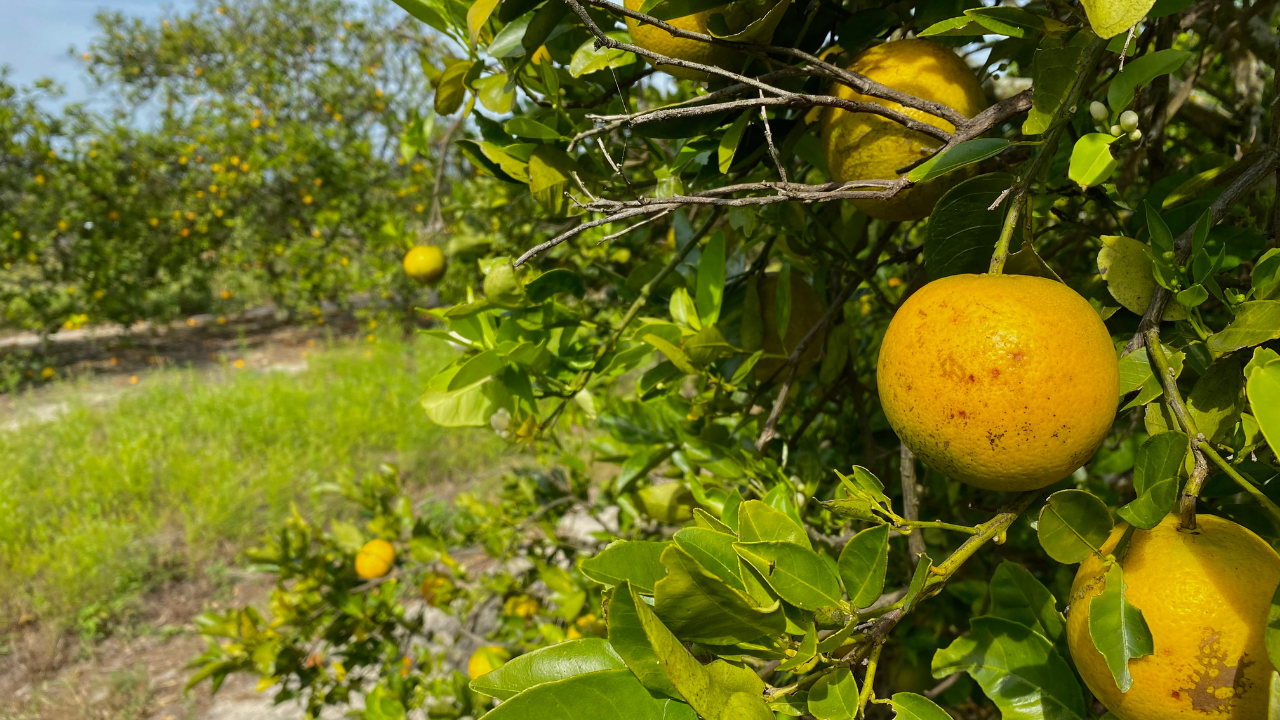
[0, 0, 529, 348]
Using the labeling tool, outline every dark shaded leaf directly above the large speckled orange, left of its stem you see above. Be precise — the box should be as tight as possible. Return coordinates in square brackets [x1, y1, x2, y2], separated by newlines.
[924, 173, 1014, 281]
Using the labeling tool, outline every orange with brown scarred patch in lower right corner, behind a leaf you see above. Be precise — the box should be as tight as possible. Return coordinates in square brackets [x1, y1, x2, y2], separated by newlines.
[1066, 515, 1280, 720]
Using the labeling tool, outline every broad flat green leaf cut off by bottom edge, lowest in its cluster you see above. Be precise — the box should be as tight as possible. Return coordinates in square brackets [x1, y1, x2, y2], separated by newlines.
[485, 670, 698, 720]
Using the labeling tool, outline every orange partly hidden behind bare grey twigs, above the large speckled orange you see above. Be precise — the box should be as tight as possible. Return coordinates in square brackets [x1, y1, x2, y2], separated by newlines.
[822, 40, 987, 220]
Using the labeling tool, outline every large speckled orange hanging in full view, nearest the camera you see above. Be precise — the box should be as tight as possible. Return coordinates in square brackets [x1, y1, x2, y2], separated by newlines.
[877, 275, 1120, 491]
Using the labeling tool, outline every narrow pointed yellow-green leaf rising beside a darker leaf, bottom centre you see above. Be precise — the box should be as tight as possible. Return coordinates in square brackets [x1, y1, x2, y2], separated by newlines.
[631, 579, 772, 719]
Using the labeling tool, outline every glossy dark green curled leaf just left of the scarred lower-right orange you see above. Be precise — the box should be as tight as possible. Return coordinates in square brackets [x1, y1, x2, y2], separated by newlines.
[932, 616, 1089, 720]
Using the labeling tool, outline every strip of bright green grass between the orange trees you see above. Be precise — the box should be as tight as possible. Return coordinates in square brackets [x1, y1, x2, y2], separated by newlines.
[0, 337, 502, 628]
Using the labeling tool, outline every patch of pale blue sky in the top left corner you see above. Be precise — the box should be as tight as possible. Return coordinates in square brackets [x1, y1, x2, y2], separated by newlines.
[0, 0, 191, 100]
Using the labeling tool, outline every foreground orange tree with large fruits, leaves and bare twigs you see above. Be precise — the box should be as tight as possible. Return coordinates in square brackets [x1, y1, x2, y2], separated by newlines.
[192, 0, 1280, 720]
